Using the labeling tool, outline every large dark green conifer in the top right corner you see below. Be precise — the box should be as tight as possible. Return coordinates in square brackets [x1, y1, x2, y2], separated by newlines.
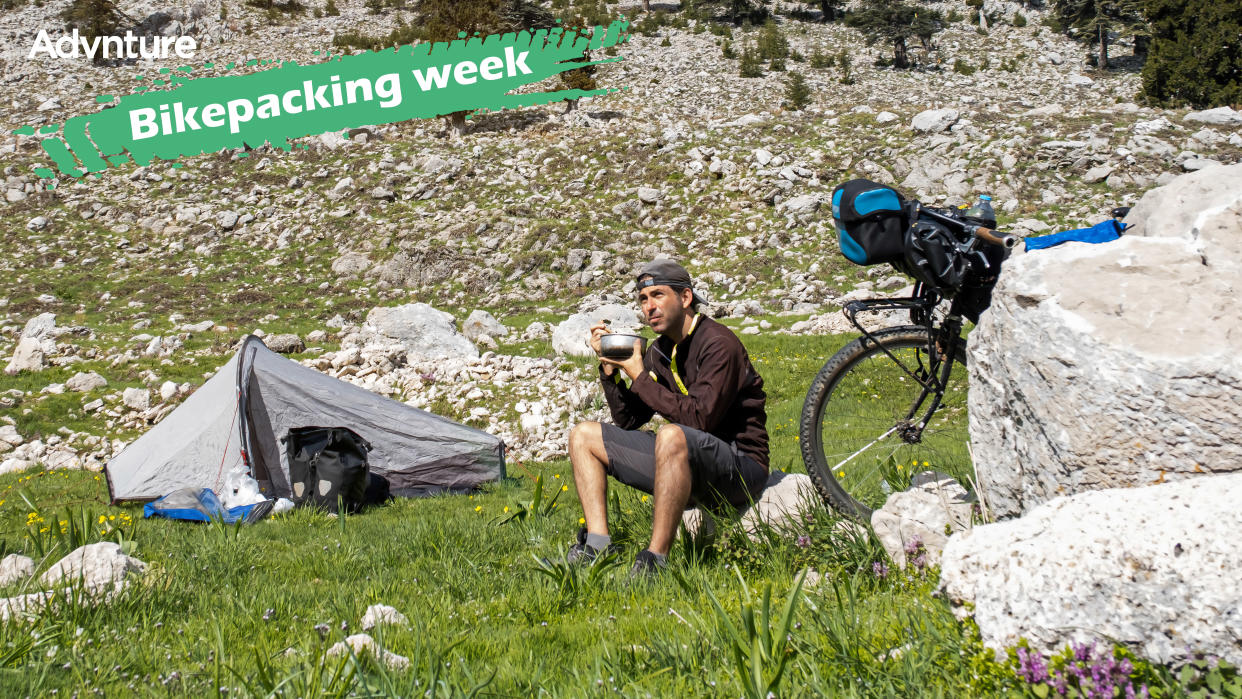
[1143, 0, 1242, 109]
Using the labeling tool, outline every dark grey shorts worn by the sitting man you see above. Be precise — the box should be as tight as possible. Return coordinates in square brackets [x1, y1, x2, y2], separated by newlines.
[600, 423, 768, 509]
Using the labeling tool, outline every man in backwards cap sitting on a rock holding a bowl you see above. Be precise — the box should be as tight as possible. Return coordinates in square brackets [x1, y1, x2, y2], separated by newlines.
[568, 259, 768, 574]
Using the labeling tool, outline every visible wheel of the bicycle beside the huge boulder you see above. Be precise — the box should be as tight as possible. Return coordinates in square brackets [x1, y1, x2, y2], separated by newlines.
[799, 325, 972, 519]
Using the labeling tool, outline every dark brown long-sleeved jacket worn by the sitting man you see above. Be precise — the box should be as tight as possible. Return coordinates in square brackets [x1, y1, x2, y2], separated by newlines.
[600, 315, 768, 468]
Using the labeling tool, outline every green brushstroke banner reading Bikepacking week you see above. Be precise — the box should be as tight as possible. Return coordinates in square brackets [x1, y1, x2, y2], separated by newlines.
[17, 20, 630, 178]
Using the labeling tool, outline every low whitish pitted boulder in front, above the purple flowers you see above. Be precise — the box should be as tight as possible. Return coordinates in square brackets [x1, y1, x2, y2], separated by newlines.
[940, 473, 1242, 664]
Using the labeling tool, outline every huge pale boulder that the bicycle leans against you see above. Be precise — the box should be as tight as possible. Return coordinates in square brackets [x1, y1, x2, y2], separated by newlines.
[969, 165, 1242, 516]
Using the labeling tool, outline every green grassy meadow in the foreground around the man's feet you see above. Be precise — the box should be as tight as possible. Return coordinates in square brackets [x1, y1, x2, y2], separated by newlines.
[0, 335, 1033, 697]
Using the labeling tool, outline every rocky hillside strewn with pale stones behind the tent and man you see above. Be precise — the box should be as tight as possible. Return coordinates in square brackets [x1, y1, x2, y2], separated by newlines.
[0, 0, 1242, 469]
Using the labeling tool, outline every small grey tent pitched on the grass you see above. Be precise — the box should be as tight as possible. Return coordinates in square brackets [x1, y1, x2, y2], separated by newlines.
[104, 335, 504, 502]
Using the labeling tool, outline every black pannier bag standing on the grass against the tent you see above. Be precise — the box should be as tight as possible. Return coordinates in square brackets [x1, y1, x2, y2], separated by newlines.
[284, 427, 374, 513]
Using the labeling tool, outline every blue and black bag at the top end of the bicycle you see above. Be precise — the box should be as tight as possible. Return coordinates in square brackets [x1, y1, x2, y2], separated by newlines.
[832, 180, 909, 264]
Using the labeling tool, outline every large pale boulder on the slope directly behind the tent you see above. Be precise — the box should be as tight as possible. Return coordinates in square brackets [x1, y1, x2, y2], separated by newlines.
[359, 303, 478, 361]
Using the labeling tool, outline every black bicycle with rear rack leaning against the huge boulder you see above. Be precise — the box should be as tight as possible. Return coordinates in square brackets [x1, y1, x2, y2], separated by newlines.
[799, 201, 1021, 520]
